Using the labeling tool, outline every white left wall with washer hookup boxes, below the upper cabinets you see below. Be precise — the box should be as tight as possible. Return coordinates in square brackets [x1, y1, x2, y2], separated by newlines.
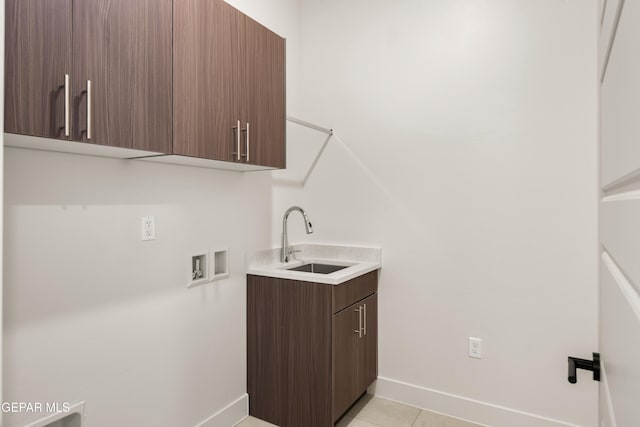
[2, 0, 298, 427]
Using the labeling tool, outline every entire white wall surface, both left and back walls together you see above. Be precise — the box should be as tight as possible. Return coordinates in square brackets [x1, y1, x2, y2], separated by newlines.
[3, 0, 597, 426]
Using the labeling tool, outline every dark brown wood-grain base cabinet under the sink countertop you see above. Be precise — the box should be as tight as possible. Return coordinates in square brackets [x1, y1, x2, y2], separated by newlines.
[247, 271, 378, 427]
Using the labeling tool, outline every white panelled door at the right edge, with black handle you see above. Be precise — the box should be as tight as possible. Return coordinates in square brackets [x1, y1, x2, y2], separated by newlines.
[599, 0, 640, 427]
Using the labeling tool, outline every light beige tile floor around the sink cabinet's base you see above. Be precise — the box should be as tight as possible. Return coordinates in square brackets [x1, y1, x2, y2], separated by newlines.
[236, 394, 480, 427]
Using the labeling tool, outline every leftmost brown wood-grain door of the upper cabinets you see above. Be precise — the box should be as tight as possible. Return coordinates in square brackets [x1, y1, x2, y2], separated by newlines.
[4, 0, 71, 139]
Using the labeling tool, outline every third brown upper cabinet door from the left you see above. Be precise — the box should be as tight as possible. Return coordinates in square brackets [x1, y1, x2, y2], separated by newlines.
[173, 0, 244, 161]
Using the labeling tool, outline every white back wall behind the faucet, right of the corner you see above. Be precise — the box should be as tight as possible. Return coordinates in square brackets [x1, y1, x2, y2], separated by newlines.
[272, 0, 597, 426]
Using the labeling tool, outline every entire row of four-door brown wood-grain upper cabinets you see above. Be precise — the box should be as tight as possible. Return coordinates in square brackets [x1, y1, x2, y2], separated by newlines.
[4, 0, 286, 170]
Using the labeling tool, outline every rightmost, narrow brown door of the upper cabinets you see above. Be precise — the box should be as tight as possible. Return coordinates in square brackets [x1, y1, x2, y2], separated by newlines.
[243, 17, 286, 168]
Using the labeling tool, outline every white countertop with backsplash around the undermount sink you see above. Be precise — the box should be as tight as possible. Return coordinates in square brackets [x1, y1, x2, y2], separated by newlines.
[247, 243, 382, 285]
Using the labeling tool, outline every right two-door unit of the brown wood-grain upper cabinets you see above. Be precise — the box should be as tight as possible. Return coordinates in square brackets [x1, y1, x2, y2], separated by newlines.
[173, 0, 285, 168]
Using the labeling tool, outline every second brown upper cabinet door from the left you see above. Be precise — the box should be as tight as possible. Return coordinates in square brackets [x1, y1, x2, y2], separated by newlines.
[73, 0, 173, 153]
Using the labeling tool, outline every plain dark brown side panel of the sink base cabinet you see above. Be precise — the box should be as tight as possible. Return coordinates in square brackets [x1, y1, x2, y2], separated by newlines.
[247, 275, 333, 427]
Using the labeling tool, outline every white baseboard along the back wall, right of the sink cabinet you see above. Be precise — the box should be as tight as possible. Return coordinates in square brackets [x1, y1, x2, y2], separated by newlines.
[369, 377, 579, 427]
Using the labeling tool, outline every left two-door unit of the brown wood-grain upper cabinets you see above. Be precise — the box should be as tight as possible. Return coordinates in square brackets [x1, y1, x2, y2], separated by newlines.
[5, 0, 172, 153]
